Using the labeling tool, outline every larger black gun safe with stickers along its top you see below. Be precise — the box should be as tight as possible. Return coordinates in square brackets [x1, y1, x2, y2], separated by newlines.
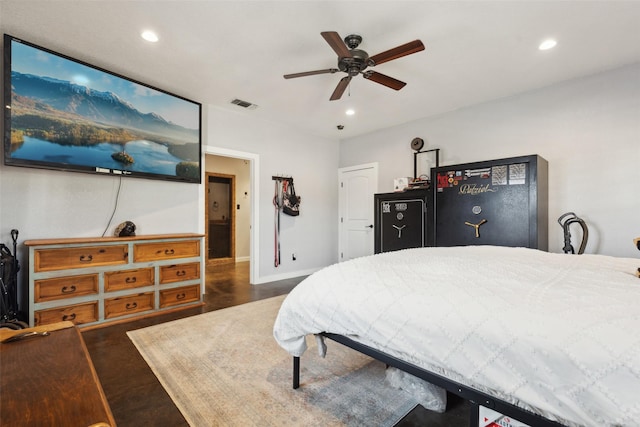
[428, 155, 549, 251]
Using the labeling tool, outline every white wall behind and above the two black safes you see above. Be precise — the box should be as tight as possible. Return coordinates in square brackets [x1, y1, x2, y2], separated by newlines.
[340, 64, 640, 258]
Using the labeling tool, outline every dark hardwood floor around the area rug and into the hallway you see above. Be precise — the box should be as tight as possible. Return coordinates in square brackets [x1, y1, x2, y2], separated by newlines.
[82, 262, 469, 427]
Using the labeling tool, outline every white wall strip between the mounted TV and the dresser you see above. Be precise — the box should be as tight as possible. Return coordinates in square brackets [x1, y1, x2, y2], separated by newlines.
[0, 165, 201, 241]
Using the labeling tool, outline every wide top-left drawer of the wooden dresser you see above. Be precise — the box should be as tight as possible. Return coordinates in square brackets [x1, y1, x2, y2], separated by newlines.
[34, 245, 129, 273]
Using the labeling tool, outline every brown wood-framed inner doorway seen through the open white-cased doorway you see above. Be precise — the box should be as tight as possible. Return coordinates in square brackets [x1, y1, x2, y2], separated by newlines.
[205, 172, 236, 264]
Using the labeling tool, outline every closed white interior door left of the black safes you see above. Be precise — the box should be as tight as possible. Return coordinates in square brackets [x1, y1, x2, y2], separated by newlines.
[338, 163, 378, 262]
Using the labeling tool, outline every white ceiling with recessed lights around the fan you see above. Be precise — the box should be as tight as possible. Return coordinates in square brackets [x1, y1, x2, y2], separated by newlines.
[0, 0, 640, 139]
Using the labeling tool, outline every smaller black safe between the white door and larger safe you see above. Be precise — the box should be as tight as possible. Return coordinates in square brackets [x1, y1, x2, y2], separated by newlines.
[374, 189, 431, 253]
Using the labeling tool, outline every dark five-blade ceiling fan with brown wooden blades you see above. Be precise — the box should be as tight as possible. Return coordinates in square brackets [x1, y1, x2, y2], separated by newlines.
[284, 31, 424, 101]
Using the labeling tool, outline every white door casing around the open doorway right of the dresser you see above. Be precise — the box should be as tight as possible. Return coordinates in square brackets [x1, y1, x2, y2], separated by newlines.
[200, 146, 260, 285]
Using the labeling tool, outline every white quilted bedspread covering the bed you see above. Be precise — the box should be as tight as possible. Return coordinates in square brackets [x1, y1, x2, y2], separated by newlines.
[274, 246, 640, 427]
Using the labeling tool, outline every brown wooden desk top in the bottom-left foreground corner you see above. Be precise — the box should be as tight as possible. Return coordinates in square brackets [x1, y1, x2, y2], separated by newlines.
[0, 322, 116, 427]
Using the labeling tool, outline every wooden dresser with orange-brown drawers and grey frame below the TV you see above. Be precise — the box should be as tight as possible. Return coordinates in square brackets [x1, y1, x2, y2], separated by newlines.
[24, 234, 204, 326]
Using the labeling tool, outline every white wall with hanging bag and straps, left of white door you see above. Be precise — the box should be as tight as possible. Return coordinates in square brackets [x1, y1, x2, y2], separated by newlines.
[206, 107, 338, 283]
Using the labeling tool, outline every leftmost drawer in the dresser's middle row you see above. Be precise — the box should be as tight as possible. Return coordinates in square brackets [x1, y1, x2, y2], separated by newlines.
[33, 274, 98, 302]
